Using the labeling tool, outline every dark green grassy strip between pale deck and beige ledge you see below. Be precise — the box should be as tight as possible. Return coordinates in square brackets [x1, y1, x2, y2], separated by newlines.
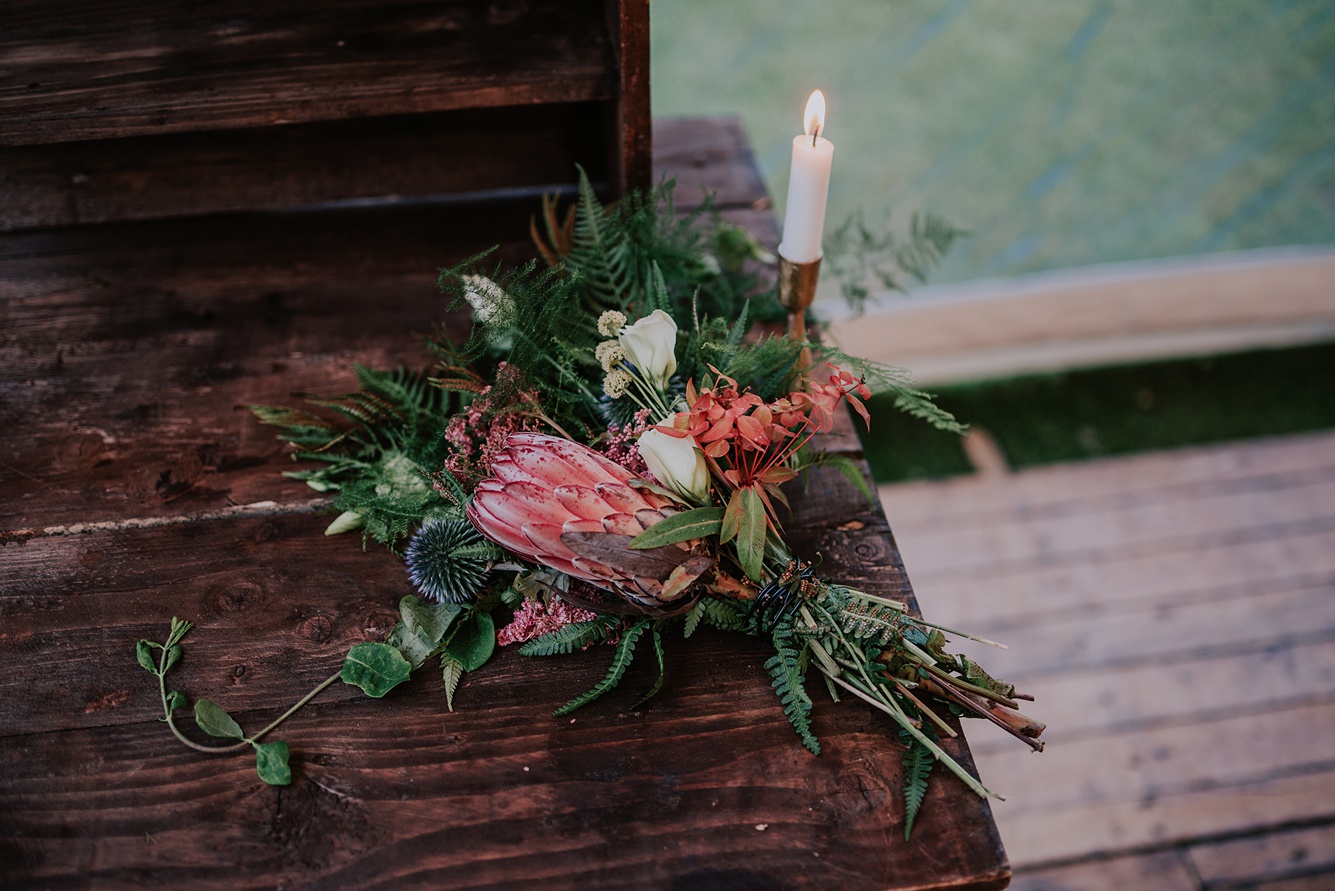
[864, 343, 1335, 482]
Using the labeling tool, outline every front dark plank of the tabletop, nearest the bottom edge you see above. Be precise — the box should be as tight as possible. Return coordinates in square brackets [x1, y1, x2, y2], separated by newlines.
[0, 675, 1005, 890]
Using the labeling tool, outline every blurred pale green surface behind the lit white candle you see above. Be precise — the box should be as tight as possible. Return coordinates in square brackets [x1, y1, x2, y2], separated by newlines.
[651, 0, 1335, 282]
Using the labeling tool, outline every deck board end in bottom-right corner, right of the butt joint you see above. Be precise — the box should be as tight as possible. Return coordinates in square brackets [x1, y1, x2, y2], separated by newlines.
[1187, 824, 1335, 887]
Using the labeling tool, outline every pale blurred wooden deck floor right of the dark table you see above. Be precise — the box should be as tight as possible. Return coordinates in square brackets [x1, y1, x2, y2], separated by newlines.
[881, 433, 1335, 891]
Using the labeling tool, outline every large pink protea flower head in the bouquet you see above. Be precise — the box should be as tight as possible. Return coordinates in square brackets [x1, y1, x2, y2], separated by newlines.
[467, 433, 714, 616]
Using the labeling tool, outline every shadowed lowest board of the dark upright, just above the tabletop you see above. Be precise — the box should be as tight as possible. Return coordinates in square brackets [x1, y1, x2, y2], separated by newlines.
[0, 103, 607, 231]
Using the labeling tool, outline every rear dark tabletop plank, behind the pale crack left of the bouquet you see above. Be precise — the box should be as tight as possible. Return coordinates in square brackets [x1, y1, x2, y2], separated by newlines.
[0, 202, 529, 529]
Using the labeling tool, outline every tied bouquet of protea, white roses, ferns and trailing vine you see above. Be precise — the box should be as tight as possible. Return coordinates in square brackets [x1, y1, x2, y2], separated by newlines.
[138, 178, 1043, 832]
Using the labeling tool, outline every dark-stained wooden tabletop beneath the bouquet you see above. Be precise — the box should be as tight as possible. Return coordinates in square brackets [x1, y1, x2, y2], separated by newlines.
[0, 114, 1009, 891]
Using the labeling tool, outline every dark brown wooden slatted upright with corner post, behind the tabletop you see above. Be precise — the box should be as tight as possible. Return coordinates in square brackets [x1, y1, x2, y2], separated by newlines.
[0, 0, 653, 231]
